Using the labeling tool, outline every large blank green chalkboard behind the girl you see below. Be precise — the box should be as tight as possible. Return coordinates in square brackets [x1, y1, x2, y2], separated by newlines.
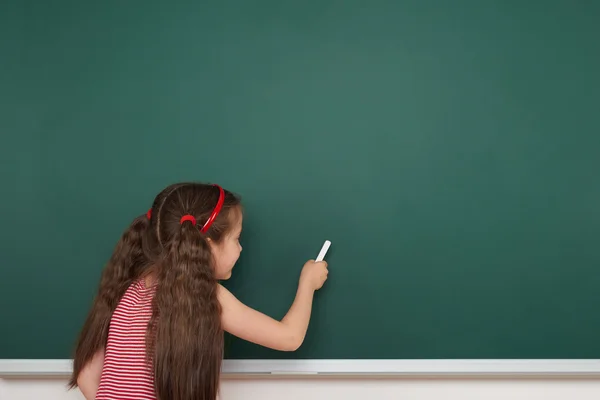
[0, 0, 600, 359]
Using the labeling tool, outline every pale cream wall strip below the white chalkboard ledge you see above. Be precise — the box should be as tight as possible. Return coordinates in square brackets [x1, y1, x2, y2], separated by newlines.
[0, 378, 600, 400]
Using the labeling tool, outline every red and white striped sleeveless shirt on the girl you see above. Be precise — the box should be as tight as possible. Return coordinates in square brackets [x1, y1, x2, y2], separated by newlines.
[96, 279, 156, 400]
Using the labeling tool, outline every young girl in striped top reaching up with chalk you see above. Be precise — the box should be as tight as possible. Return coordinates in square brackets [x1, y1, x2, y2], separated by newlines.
[70, 183, 328, 400]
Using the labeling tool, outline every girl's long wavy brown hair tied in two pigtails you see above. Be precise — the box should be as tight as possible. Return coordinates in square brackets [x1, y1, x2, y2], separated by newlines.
[70, 183, 241, 400]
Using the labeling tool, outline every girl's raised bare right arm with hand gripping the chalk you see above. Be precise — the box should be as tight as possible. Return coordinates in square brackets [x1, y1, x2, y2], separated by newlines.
[218, 260, 328, 351]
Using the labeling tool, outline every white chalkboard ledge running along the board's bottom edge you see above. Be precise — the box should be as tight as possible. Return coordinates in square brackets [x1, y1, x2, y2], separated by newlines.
[0, 359, 600, 378]
